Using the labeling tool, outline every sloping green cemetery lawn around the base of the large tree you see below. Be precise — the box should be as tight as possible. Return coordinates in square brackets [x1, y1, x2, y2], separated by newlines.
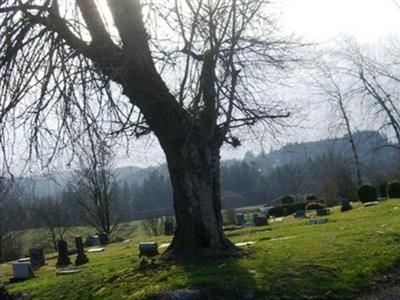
[0, 200, 400, 300]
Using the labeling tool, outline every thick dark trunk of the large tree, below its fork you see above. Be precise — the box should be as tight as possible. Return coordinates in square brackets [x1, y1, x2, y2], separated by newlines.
[165, 138, 236, 255]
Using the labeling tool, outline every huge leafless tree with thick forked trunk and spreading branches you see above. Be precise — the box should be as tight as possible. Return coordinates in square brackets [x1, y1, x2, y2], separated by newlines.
[0, 0, 297, 254]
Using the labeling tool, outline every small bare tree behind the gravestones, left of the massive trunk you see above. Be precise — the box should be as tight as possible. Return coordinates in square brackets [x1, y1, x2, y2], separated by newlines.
[70, 132, 122, 234]
